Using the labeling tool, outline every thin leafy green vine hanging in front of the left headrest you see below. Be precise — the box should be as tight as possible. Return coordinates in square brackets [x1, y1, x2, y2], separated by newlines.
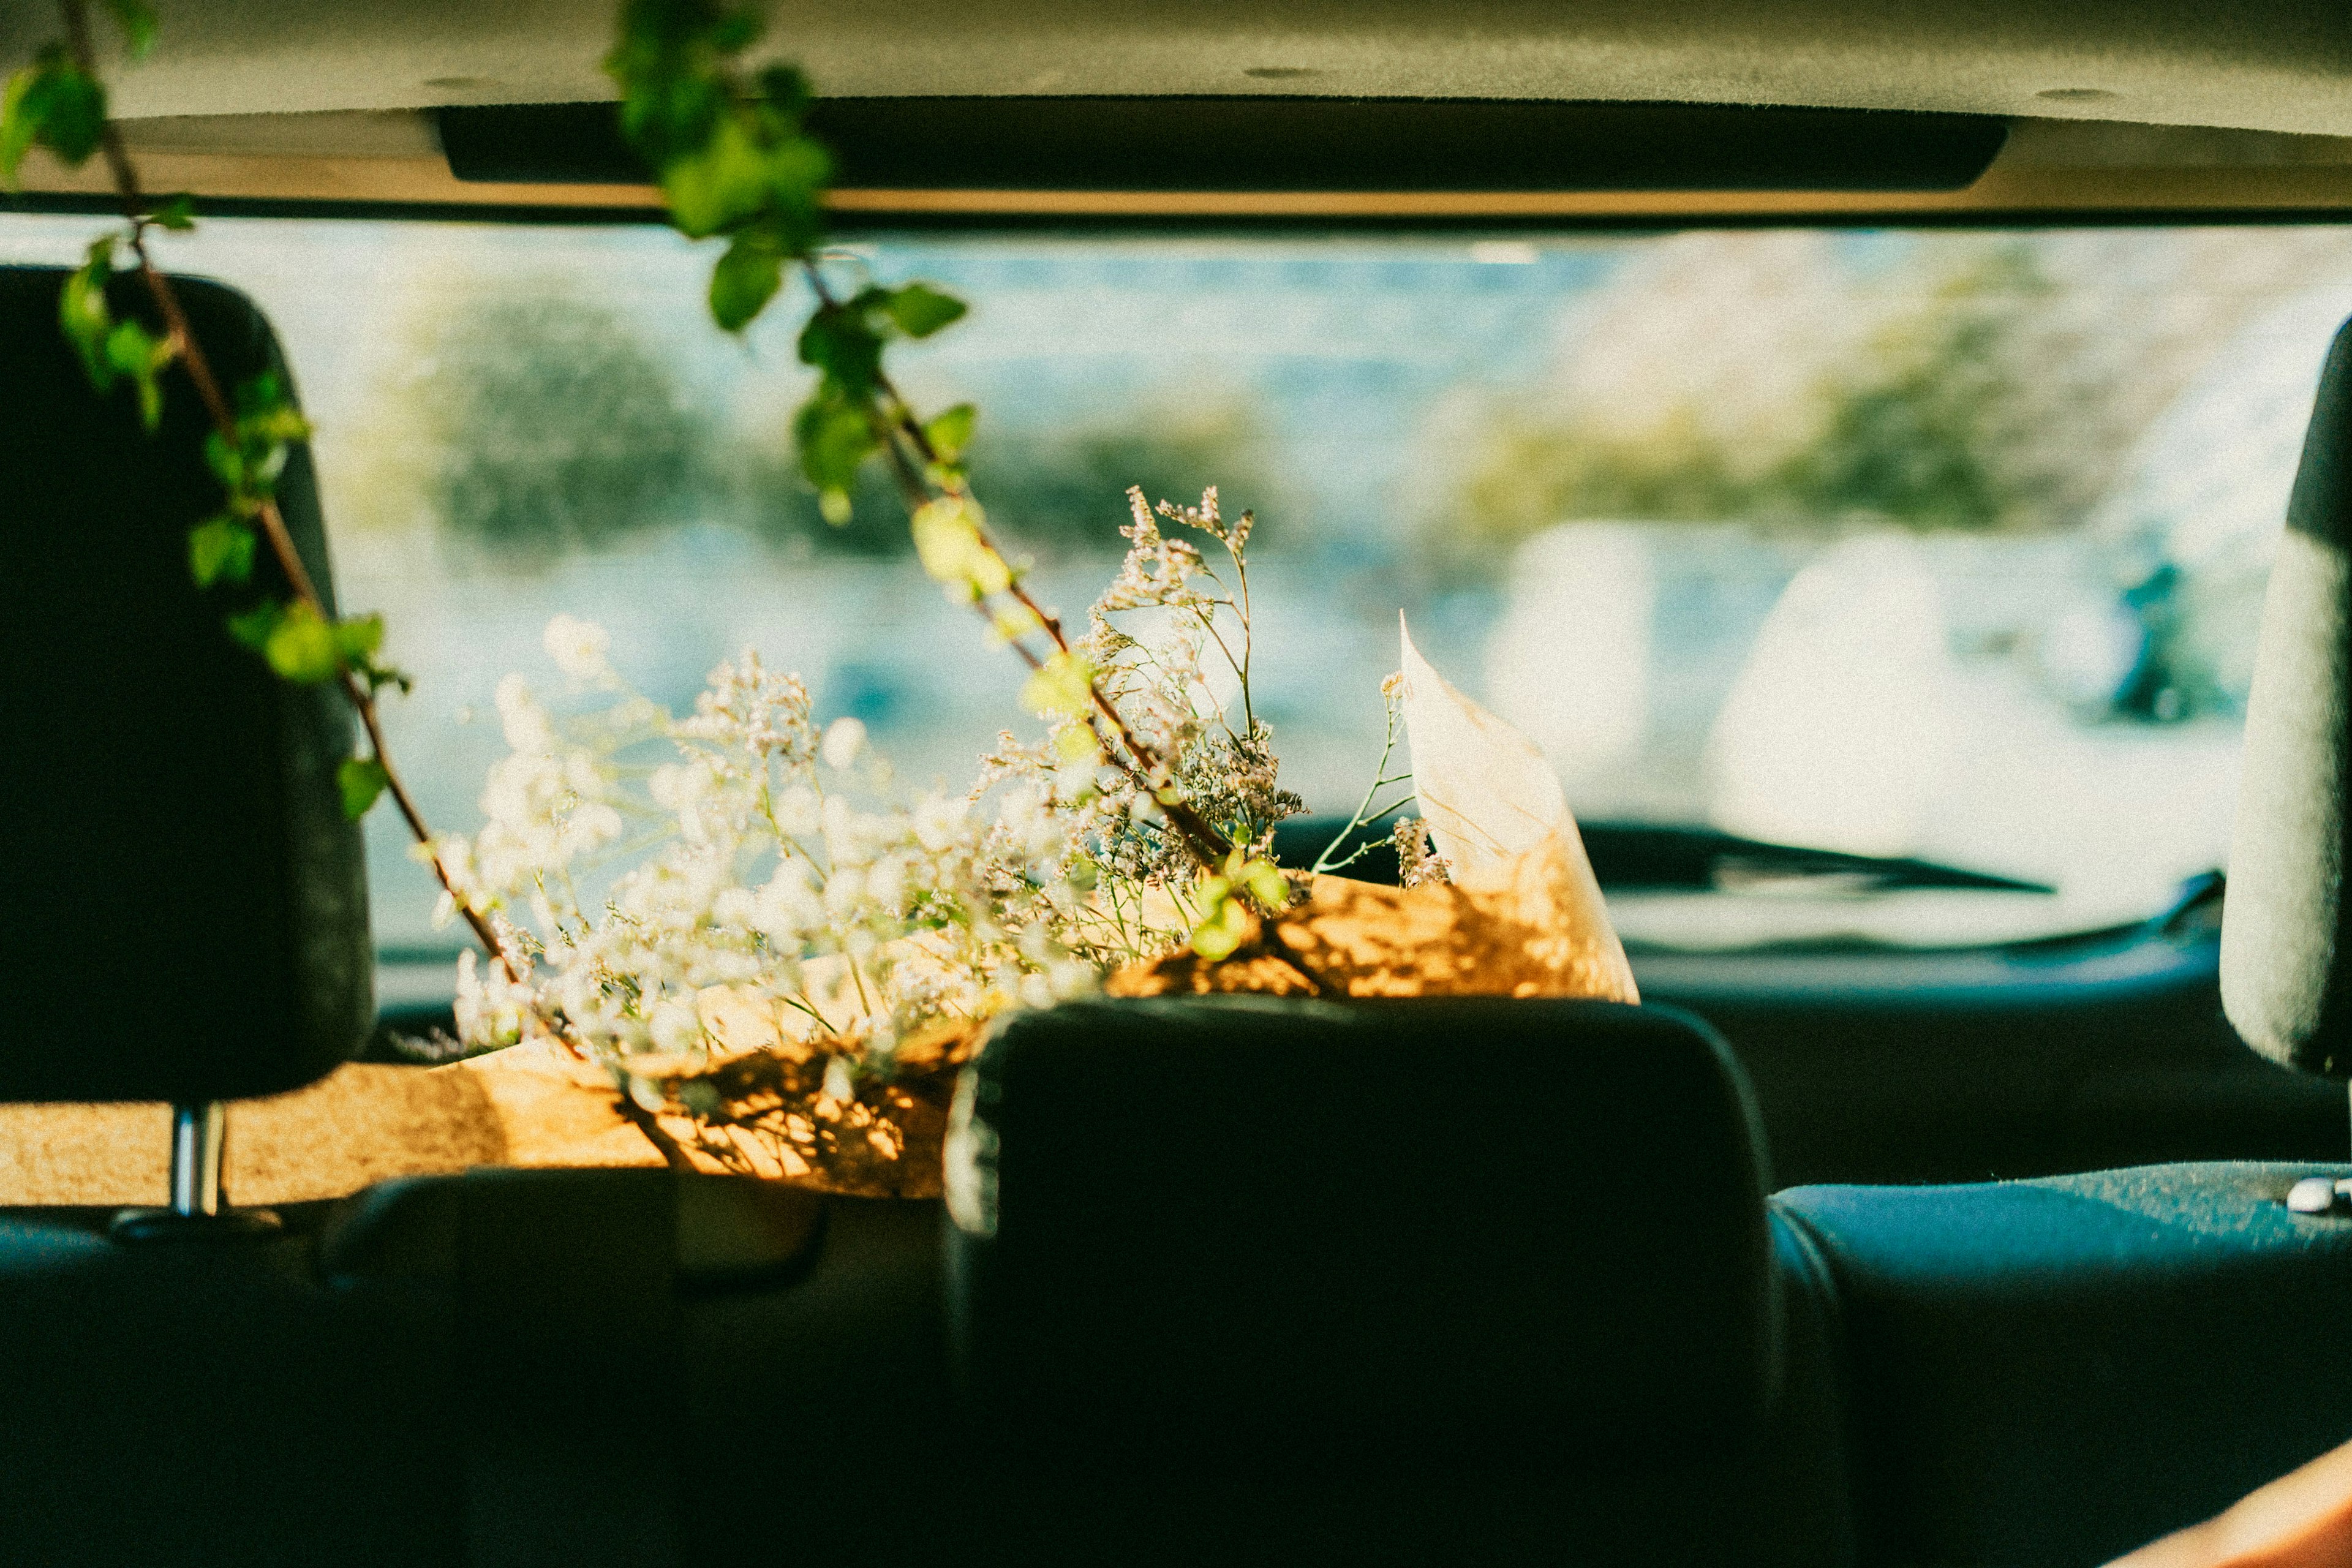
[0, 0, 513, 971]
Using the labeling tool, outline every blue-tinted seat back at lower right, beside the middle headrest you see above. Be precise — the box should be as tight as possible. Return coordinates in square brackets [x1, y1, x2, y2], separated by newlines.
[1773, 1164, 2352, 1568]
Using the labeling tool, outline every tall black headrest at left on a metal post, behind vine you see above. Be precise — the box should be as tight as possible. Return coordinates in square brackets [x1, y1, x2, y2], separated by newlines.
[0, 268, 374, 1102]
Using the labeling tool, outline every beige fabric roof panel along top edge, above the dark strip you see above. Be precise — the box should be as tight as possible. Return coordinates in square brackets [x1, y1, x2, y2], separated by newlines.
[0, 0, 2352, 137]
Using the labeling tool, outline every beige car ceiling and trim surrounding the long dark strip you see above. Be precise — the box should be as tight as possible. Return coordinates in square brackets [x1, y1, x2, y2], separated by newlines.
[0, 0, 2352, 219]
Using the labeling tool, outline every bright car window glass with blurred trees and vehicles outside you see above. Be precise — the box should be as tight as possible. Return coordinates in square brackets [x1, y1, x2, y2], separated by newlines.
[0, 214, 2352, 954]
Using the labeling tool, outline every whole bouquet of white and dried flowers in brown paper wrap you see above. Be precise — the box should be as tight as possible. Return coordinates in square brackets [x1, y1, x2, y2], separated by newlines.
[435, 489, 1635, 1197]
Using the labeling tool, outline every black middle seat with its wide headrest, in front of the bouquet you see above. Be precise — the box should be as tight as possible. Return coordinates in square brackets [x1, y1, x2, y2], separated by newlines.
[948, 999, 1849, 1566]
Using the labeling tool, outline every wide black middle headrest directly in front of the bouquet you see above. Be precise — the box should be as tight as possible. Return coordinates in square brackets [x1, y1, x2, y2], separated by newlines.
[948, 997, 1773, 1464]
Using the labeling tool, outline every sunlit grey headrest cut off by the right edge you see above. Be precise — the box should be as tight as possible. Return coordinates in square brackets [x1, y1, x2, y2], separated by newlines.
[2220, 326, 2352, 1079]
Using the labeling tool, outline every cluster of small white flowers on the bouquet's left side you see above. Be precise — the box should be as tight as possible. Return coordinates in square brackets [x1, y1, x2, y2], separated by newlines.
[440, 616, 1096, 1175]
